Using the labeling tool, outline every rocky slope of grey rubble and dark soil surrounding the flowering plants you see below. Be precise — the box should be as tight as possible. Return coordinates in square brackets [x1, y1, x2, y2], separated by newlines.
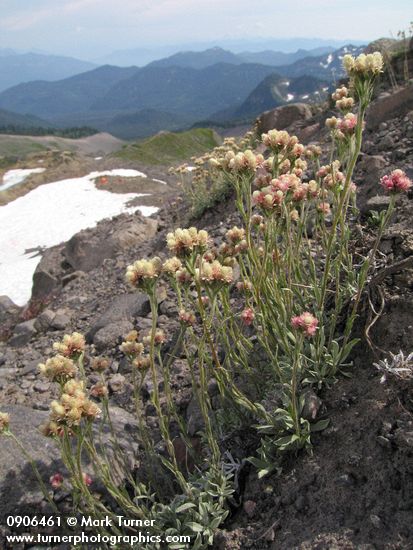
[0, 72, 413, 550]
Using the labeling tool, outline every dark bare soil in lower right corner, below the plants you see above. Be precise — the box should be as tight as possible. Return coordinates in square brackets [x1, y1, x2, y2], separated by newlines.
[216, 342, 413, 550]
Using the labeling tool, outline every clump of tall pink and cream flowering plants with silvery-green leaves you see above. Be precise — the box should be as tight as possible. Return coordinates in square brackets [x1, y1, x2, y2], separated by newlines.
[0, 53, 412, 550]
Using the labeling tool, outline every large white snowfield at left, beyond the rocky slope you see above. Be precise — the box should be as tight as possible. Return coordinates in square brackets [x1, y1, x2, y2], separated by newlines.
[0, 169, 158, 306]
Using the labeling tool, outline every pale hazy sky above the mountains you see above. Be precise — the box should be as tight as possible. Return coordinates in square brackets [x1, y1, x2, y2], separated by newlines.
[0, 0, 413, 59]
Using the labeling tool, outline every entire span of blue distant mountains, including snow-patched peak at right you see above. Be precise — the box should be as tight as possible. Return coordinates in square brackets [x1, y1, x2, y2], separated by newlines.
[0, 45, 361, 139]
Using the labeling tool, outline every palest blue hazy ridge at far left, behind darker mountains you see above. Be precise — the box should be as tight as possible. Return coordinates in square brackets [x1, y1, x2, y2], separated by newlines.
[0, 49, 96, 91]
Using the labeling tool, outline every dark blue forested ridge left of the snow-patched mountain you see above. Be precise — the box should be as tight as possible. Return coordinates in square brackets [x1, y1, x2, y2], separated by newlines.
[0, 63, 274, 127]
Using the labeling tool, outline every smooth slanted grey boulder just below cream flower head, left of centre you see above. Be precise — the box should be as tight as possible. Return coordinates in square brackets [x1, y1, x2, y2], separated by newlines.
[86, 292, 150, 343]
